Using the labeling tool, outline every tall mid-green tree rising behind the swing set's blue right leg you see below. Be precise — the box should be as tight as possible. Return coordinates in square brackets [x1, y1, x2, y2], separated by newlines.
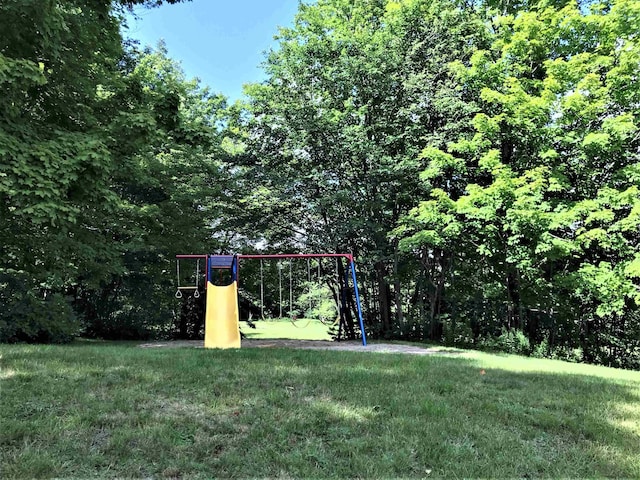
[242, 0, 484, 334]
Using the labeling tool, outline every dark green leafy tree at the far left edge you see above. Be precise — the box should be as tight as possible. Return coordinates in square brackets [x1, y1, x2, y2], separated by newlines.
[0, 1, 136, 337]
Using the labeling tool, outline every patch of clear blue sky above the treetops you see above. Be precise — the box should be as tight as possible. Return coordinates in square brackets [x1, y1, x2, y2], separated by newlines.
[124, 0, 298, 102]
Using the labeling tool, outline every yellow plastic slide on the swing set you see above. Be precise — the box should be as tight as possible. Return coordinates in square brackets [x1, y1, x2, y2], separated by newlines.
[204, 282, 240, 348]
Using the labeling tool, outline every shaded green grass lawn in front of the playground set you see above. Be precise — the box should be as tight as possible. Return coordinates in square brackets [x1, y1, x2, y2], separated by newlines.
[0, 343, 640, 478]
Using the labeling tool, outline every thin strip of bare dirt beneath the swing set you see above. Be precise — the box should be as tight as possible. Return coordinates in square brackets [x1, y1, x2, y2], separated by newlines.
[139, 338, 463, 355]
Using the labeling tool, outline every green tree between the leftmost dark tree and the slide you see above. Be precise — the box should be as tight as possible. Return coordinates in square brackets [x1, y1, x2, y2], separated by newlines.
[75, 44, 231, 337]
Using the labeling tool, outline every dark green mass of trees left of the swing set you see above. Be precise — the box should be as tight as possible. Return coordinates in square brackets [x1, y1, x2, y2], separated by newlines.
[0, 0, 230, 340]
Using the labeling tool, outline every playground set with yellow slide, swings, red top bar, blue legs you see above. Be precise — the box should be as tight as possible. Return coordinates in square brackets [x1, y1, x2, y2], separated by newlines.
[176, 253, 367, 348]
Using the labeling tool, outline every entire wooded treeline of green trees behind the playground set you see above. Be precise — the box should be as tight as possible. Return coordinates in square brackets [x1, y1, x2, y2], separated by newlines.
[0, 0, 640, 368]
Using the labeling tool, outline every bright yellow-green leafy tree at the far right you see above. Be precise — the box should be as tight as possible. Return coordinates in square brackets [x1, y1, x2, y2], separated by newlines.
[397, 0, 640, 367]
